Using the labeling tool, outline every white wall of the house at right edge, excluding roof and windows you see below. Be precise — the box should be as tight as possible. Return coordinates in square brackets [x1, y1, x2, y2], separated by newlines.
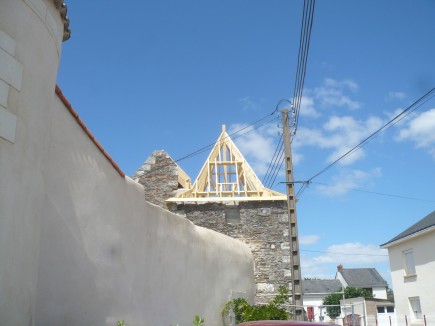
[387, 230, 435, 324]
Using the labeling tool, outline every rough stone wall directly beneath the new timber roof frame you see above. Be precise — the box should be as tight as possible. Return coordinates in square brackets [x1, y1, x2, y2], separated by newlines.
[171, 201, 291, 303]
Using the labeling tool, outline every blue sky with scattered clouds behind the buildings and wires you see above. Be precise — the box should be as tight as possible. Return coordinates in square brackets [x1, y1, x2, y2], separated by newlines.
[58, 0, 435, 285]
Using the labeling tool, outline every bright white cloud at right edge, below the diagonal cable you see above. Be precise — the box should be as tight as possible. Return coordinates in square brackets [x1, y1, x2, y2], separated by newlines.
[398, 109, 435, 158]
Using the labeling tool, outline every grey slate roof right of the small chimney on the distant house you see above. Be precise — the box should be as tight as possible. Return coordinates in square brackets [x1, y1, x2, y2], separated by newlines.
[337, 268, 388, 287]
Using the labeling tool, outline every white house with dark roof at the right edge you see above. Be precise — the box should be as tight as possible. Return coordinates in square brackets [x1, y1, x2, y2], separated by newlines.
[381, 211, 435, 325]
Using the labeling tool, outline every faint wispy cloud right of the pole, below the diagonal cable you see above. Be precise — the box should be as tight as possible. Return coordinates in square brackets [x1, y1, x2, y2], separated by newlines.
[316, 168, 382, 197]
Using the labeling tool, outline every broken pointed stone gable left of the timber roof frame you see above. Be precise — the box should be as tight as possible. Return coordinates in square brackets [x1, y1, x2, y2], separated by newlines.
[131, 150, 178, 209]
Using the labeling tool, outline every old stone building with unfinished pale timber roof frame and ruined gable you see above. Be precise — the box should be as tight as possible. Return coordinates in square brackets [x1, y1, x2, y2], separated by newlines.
[132, 126, 291, 302]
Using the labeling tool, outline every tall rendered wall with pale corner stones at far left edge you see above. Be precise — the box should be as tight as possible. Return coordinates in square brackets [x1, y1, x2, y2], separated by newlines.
[0, 0, 63, 326]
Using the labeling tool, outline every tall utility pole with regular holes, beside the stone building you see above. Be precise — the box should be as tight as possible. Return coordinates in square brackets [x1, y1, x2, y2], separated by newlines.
[282, 109, 304, 321]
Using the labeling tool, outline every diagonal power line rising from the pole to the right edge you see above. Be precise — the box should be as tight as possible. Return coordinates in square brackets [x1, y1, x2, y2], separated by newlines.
[307, 88, 435, 182]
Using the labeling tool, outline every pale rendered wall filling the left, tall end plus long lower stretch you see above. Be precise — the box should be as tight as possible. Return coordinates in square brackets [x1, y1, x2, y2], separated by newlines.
[0, 0, 254, 326]
